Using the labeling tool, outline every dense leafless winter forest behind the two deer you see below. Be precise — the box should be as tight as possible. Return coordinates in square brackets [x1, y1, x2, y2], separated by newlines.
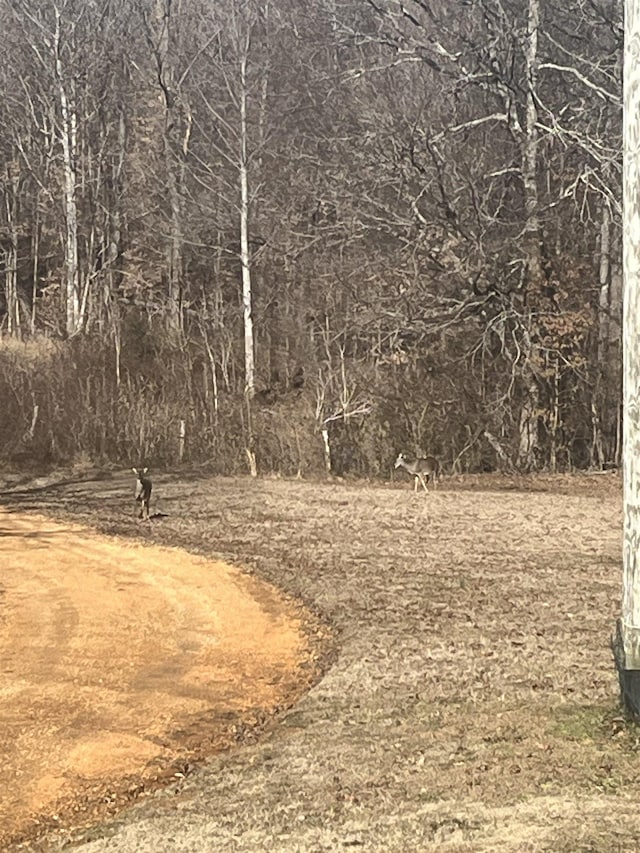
[0, 0, 623, 478]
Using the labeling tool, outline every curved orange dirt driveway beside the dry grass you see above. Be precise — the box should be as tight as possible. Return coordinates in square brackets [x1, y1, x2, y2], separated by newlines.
[0, 508, 309, 850]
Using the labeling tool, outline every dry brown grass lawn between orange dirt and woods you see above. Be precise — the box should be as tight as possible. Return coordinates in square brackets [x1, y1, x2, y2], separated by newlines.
[0, 475, 640, 853]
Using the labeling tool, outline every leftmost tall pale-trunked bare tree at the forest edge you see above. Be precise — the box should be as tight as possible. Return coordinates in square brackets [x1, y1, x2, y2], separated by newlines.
[2, 0, 135, 337]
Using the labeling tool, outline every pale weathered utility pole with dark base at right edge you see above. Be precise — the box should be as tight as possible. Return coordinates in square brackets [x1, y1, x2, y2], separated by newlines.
[613, 0, 640, 718]
